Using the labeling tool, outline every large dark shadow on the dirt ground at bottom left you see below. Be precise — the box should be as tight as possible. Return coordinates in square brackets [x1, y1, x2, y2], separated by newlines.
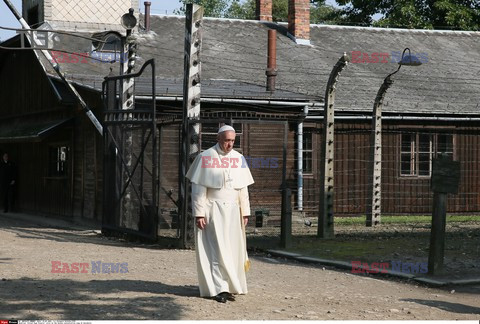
[0, 278, 198, 320]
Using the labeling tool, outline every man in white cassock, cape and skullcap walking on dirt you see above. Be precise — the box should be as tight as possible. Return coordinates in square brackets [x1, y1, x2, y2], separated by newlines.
[186, 125, 254, 303]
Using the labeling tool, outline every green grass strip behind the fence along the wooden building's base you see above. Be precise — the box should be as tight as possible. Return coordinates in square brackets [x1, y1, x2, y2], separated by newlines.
[248, 215, 480, 275]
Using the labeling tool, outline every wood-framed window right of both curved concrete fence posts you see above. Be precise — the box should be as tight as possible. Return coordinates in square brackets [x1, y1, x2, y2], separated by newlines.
[400, 133, 454, 177]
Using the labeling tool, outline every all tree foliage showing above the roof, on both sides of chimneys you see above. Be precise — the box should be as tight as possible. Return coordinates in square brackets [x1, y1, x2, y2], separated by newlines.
[172, 0, 480, 30]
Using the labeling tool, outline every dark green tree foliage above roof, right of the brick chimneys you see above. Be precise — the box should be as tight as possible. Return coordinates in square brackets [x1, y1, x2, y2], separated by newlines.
[336, 0, 480, 30]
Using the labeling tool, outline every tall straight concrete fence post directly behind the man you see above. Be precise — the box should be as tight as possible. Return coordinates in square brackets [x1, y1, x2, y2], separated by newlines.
[179, 3, 203, 248]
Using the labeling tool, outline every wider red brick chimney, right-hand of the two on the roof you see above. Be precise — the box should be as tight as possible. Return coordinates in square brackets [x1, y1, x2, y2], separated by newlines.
[288, 0, 310, 44]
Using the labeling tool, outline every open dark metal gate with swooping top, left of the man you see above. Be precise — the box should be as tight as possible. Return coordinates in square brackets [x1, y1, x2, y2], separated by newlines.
[102, 59, 158, 241]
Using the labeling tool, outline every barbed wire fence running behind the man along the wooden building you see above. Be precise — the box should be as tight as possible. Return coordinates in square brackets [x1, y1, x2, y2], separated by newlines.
[155, 118, 480, 246]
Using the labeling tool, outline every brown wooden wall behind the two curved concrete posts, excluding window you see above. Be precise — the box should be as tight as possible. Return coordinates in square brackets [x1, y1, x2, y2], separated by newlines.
[304, 121, 480, 216]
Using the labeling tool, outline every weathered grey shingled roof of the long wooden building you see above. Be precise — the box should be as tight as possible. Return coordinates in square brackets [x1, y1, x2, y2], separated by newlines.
[24, 15, 480, 115]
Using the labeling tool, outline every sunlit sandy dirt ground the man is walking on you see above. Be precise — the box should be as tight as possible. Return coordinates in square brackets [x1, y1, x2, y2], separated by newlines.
[0, 215, 480, 320]
